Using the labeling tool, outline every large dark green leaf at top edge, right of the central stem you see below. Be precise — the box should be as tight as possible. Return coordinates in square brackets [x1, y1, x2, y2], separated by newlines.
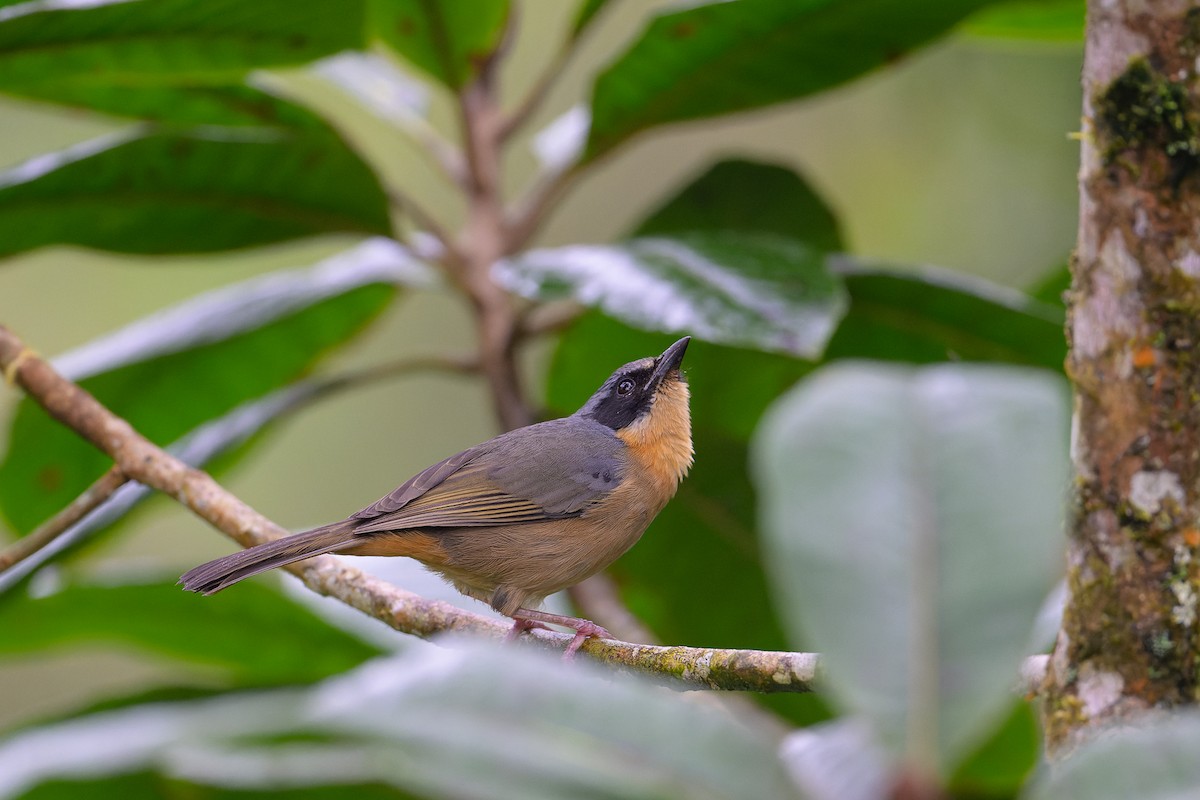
[584, 0, 989, 160]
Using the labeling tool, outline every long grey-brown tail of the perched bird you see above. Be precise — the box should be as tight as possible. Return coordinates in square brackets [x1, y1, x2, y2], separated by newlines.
[179, 519, 360, 595]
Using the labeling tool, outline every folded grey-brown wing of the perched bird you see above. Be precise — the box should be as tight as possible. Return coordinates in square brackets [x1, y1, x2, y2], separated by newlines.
[354, 417, 625, 534]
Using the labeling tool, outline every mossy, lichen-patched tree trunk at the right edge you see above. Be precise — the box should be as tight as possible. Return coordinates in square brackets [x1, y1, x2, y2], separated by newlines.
[1044, 0, 1200, 753]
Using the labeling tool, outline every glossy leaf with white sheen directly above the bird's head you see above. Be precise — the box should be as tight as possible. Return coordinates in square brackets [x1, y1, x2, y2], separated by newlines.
[493, 231, 846, 359]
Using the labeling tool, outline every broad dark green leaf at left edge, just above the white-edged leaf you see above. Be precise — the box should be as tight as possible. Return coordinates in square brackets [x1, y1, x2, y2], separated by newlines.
[0, 130, 391, 255]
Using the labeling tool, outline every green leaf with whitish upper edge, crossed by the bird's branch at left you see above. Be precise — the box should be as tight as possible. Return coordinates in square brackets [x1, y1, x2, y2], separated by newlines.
[0, 240, 427, 533]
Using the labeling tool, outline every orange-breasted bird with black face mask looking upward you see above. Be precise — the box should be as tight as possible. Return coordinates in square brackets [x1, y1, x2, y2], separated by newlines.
[179, 336, 694, 660]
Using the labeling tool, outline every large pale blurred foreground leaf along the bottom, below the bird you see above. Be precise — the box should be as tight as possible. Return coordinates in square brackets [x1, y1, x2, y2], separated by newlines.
[0, 643, 797, 800]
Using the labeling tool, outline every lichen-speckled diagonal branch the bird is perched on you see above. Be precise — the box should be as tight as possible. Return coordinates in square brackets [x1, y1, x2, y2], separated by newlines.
[0, 326, 817, 692]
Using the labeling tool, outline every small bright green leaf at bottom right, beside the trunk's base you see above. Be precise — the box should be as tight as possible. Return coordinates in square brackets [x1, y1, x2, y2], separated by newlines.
[949, 700, 1042, 799]
